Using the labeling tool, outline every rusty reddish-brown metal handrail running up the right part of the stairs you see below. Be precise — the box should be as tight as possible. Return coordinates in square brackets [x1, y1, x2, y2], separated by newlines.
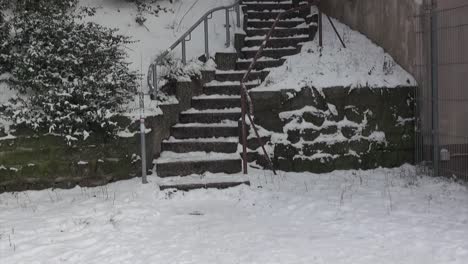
[240, 0, 320, 175]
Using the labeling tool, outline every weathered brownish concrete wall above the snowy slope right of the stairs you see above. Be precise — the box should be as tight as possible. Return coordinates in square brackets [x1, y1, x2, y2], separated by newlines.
[322, 0, 423, 76]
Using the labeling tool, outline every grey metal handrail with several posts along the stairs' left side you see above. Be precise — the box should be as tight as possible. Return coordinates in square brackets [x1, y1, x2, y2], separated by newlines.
[147, 0, 241, 97]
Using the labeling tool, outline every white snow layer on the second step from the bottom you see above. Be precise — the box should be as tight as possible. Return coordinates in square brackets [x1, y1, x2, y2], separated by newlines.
[155, 151, 240, 164]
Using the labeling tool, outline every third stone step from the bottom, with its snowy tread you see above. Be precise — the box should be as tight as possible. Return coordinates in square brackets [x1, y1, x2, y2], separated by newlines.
[162, 137, 239, 153]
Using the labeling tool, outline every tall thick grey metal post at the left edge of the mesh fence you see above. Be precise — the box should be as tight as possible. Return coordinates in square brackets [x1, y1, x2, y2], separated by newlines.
[430, 3, 440, 176]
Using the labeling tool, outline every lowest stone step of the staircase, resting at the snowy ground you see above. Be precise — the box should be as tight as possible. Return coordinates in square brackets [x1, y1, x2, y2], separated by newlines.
[158, 174, 250, 191]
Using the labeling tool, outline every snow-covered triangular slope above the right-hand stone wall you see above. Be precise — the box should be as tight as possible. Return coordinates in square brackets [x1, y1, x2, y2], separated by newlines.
[253, 17, 416, 91]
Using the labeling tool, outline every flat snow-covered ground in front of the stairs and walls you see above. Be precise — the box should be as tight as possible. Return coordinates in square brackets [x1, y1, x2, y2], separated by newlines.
[0, 166, 468, 264]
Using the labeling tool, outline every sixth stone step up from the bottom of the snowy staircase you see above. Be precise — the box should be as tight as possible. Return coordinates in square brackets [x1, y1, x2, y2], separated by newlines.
[192, 94, 240, 110]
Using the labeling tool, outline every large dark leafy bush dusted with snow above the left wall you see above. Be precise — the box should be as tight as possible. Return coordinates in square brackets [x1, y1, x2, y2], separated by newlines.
[1, 0, 138, 135]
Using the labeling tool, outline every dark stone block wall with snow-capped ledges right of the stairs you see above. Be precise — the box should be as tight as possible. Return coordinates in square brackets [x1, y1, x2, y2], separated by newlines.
[249, 87, 414, 173]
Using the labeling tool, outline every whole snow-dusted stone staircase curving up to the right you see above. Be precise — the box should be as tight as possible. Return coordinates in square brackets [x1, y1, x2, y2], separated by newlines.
[155, 1, 316, 190]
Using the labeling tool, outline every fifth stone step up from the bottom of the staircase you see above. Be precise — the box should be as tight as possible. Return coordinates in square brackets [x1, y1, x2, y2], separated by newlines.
[179, 108, 241, 123]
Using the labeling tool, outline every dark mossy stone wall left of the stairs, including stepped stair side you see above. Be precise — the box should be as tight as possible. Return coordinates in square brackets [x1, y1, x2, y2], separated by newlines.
[0, 72, 208, 193]
